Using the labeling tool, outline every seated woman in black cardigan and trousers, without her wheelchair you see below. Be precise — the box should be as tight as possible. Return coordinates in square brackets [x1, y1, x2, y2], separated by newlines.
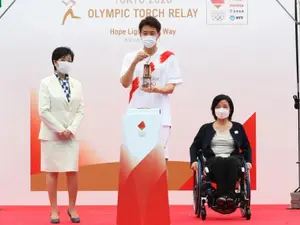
[190, 95, 252, 205]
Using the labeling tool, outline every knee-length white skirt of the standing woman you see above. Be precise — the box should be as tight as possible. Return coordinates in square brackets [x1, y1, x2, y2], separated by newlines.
[41, 140, 79, 172]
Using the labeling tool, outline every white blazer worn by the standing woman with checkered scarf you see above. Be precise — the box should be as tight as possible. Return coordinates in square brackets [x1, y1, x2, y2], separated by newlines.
[38, 74, 84, 140]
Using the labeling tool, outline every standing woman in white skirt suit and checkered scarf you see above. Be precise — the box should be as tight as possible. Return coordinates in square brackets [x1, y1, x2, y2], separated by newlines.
[38, 47, 84, 223]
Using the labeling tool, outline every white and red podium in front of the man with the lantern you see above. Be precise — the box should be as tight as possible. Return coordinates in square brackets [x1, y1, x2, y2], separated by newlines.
[117, 109, 170, 225]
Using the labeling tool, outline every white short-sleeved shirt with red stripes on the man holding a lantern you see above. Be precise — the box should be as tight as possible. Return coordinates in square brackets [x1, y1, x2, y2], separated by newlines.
[121, 48, 183, 126]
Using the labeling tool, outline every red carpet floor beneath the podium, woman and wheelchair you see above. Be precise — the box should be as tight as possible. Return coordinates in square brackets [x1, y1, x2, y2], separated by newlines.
[0, 205, 300, 225]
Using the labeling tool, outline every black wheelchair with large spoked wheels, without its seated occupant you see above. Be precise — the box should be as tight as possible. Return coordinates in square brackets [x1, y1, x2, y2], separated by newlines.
[193, 155, 251, 220]
